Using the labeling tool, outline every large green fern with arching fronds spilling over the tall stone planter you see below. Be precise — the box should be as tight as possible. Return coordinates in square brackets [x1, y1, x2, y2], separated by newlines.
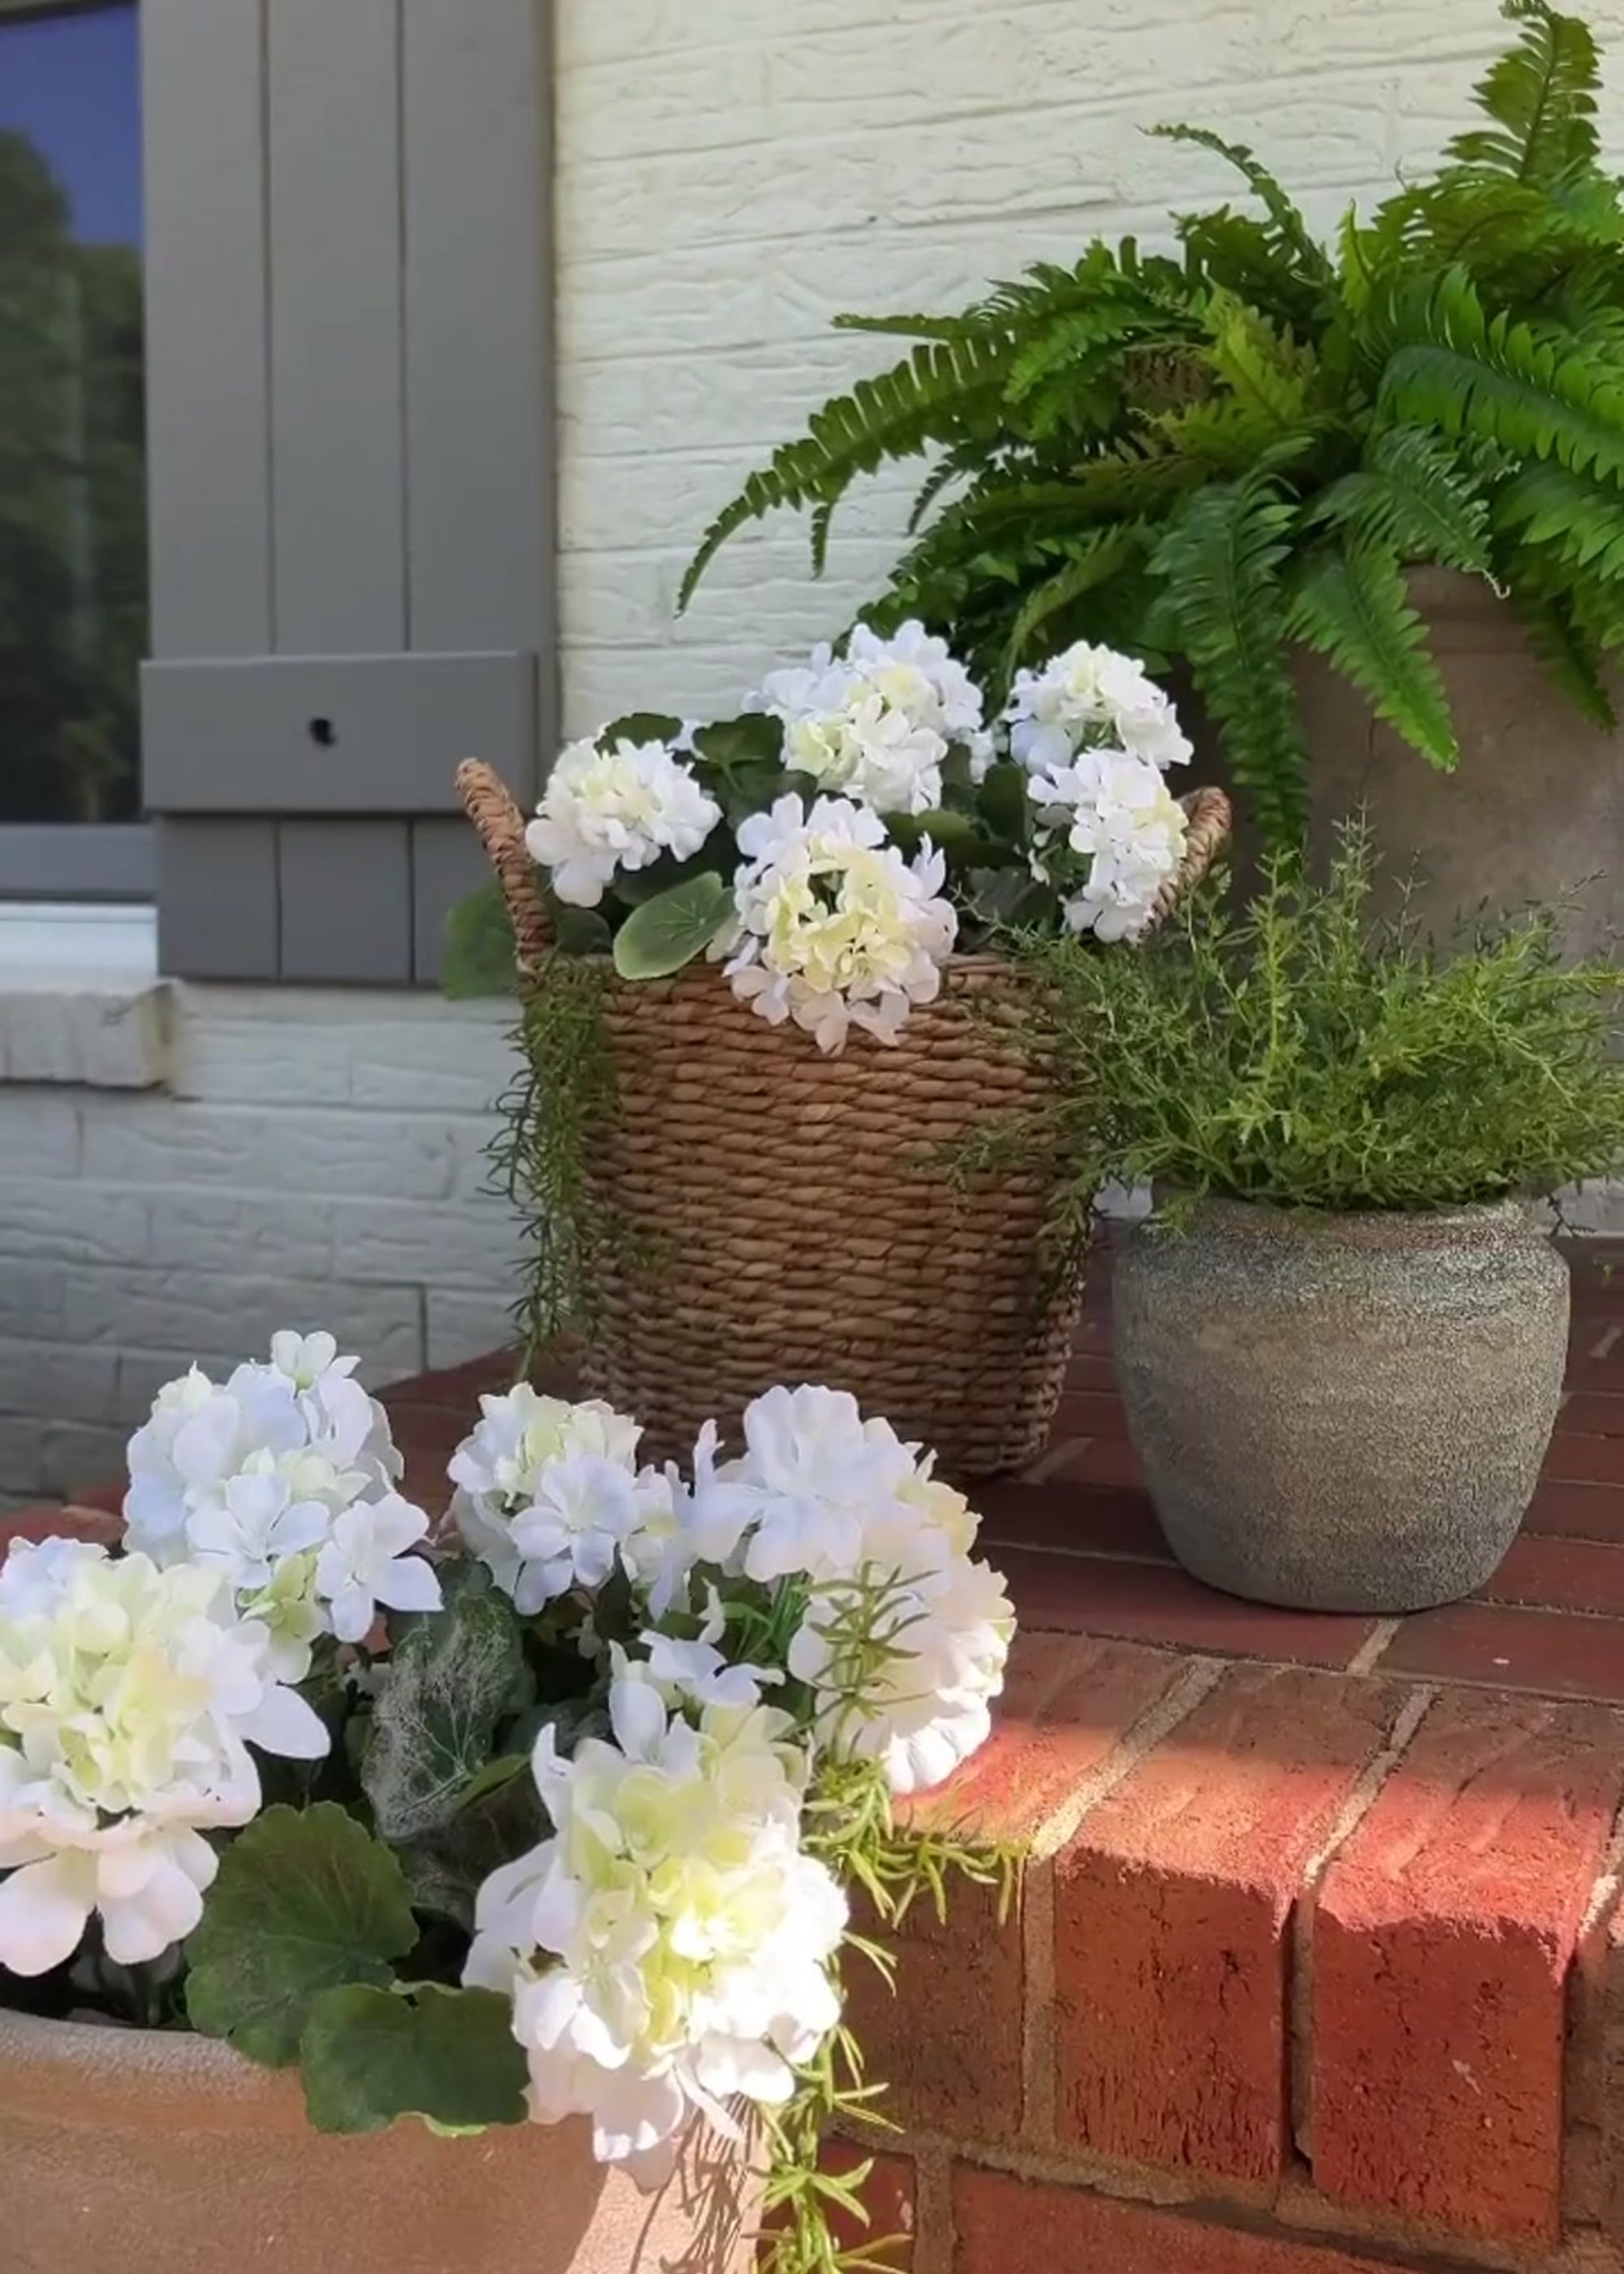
[680, 0, 1624, 846]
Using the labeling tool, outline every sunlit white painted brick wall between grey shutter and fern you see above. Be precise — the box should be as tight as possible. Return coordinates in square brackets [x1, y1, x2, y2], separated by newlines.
[557, 0, 1624, 733]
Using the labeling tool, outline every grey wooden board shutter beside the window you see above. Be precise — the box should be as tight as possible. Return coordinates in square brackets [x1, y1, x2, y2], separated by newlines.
[141, 0, 553, 983]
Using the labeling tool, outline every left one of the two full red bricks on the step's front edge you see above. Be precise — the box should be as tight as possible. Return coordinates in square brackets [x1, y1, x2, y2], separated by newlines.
[1056, 1667, 1399, 2190]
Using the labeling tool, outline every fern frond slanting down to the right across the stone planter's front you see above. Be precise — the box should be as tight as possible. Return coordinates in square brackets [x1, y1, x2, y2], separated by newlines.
[1289, 539, 1460, 771]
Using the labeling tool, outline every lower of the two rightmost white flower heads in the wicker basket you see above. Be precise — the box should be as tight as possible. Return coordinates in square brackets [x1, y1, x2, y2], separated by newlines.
[1026, 750, 1187, 941]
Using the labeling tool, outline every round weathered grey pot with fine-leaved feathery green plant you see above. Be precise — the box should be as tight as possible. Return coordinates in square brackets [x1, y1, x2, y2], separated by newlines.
[1009, 828, 1624, 1612]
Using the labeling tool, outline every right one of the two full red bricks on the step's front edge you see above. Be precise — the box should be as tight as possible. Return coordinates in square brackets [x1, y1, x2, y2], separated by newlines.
[1312, 1692, 1624, 2242]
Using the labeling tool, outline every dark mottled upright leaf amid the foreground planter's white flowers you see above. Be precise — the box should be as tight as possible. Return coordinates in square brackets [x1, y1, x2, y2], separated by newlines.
[361, 1563, 525, 1840]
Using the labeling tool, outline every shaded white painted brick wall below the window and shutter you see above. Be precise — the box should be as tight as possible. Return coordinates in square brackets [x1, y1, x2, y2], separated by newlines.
[0, 987, 516, 1507]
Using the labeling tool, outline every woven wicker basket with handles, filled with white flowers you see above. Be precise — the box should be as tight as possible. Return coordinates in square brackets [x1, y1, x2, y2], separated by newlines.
[451, 623, 1229, 1476]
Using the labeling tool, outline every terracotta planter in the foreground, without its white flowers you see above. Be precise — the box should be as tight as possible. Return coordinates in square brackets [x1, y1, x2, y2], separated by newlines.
[0, 2012, 755, 2274]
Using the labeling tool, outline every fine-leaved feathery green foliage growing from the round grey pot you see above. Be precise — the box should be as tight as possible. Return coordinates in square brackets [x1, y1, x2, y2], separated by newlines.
[1009, 828, 1624, 1212]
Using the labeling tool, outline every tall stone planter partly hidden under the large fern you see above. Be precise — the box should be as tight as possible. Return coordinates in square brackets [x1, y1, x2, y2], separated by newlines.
[1292, 568, 1624, 953]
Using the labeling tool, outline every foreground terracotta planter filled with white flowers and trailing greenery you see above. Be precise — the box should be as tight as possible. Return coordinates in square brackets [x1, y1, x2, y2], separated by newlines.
[0, 1333, 1012, 2274]
